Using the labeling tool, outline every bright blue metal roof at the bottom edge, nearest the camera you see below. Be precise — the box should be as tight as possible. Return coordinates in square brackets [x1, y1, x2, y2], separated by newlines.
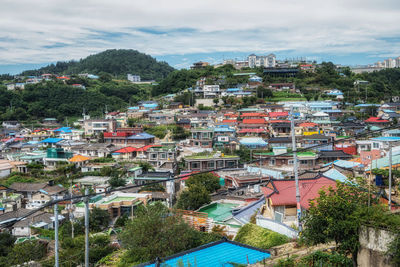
[138, 240, 271, 267]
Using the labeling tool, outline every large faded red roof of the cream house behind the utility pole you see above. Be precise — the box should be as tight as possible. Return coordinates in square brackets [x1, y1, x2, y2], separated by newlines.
[261, 176, 336, 209]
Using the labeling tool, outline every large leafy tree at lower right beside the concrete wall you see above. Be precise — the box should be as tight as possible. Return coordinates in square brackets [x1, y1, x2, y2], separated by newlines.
[303, 183, 376, 266]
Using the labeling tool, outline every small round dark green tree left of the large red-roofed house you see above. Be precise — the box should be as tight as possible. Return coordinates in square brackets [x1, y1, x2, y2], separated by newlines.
[176, 184, 211, 210]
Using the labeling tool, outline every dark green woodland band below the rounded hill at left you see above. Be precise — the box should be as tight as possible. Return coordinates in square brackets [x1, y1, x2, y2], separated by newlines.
[0, 78, 149, 122]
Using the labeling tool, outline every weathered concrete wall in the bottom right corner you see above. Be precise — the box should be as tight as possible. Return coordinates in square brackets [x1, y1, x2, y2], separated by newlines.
[357, 226, 394, 267]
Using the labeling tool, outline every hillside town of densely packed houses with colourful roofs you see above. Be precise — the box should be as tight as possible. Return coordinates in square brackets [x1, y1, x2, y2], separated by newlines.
[0, 54, 400, 266]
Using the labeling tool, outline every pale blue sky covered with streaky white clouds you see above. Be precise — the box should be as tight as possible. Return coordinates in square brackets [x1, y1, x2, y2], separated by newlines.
[0, 0, 400, 74]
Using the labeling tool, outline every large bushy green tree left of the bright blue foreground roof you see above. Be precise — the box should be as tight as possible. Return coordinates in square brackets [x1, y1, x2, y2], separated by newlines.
[120, 202, 219, 264]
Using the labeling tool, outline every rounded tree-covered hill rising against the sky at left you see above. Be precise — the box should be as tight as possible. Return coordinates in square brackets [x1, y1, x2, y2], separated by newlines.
[22, 49, 174, 80]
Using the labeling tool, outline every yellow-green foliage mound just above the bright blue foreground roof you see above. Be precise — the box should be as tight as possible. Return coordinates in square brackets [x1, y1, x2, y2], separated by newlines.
[235, 223, 289, 249]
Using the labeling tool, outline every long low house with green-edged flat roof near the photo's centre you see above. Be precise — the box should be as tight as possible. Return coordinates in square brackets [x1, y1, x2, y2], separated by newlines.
[184, 153, 240, 171]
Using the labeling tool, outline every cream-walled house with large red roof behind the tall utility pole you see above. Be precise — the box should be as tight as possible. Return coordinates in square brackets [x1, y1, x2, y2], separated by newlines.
[261, 176, 336, 227]
